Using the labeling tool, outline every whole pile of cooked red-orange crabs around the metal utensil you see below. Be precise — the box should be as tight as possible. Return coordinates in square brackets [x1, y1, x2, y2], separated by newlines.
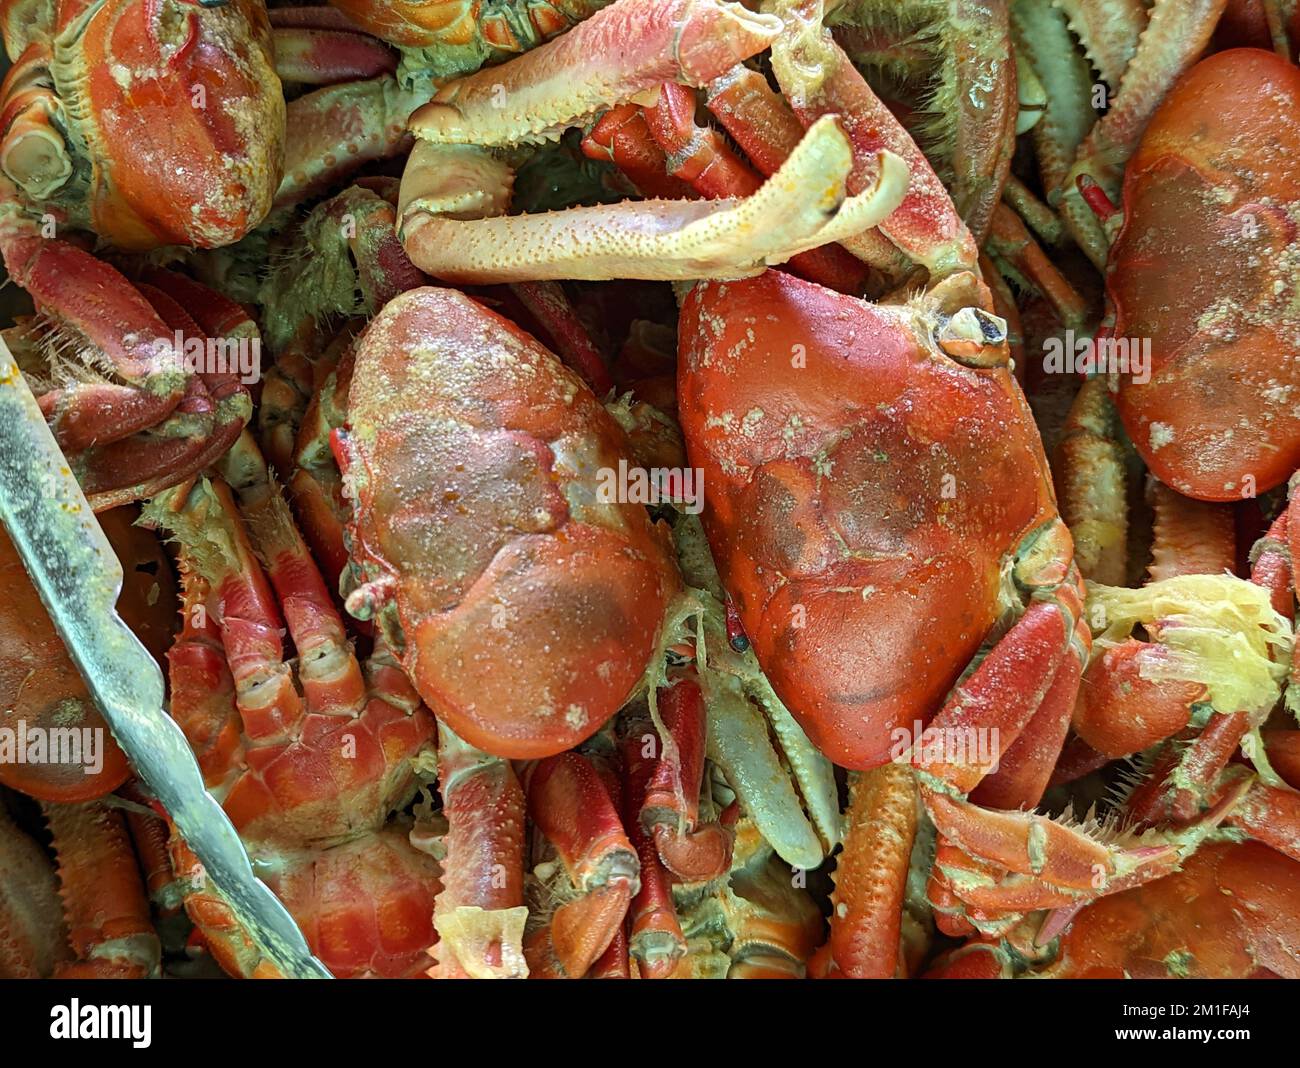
[0, 0, 1300, 978]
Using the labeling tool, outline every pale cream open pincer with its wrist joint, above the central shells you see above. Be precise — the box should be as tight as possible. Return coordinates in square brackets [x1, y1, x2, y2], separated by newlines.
[399, 116, 907, 283]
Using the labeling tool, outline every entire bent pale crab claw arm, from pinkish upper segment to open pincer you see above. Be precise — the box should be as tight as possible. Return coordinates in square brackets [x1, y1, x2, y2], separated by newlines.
[400, 0, 906, 282]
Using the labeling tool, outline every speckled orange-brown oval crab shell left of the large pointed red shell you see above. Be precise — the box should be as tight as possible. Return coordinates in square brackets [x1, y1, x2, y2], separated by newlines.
[335, 287, 680, 759]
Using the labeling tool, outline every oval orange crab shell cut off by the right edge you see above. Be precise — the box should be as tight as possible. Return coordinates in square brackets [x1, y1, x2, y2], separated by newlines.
[1108, 48, 1300, 500]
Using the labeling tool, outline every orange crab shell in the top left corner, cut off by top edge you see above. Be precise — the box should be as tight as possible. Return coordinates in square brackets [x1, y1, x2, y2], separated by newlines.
[36, 0, 285, 249]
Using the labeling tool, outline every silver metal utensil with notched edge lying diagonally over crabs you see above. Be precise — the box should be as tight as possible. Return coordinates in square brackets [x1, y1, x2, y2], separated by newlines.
[0, 338, 330, 978]
